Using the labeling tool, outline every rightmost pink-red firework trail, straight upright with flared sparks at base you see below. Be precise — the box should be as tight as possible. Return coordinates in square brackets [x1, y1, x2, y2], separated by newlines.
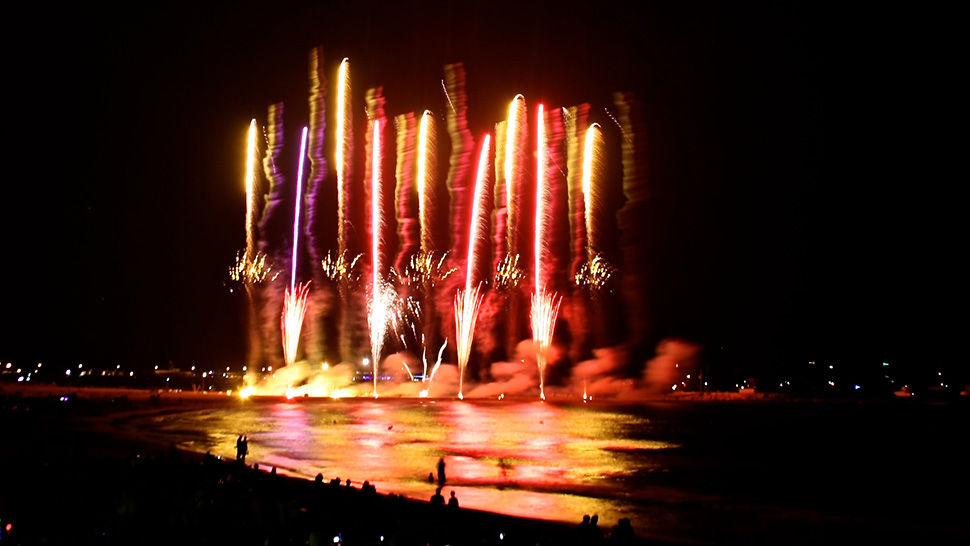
[530, 104, 562, 400]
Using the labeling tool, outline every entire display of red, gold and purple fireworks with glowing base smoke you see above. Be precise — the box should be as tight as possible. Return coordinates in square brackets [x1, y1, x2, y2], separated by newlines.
[237, 53, 636, 399]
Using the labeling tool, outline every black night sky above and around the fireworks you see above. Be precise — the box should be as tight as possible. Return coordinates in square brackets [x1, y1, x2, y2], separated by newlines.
[0, 1, 944, 386]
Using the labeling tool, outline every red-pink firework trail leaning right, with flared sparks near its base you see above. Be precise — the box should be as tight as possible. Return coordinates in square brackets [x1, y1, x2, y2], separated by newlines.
[455, 134, 490, 399]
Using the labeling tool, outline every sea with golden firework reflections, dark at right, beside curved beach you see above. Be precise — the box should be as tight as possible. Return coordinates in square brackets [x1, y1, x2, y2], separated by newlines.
[115, 398, 970, 544]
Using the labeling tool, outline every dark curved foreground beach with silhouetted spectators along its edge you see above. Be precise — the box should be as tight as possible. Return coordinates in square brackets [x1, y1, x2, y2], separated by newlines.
[0, 388, 656, 546]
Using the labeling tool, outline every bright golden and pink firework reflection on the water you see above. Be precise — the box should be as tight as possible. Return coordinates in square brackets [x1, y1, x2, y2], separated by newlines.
[129, 399, 677, 521]
